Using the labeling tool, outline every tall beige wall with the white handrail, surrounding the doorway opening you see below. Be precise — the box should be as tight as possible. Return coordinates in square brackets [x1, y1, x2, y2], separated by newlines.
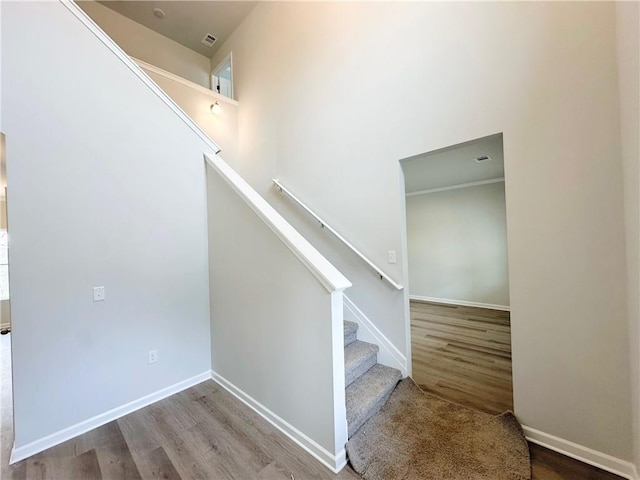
[212, 2, 632, 460]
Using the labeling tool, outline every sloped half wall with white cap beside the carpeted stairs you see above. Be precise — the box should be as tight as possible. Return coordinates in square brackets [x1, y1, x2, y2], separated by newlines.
[205, 155, 351, 472]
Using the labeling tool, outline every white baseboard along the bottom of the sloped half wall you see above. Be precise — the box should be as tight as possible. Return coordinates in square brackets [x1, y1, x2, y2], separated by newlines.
[211, 371, 347, 473]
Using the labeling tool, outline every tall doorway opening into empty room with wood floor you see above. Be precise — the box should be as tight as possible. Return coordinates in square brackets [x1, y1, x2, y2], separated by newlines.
[401, 134, 513, 413]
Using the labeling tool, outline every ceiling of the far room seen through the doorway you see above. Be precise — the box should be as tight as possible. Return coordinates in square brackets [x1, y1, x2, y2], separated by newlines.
[402, 134, 504, 193]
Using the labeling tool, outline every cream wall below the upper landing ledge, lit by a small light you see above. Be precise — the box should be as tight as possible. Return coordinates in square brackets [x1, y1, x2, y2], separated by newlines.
[142, 67, 238, 166]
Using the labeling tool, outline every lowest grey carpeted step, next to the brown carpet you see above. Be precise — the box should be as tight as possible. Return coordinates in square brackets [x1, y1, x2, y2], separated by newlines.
[346, 364, 402, 438]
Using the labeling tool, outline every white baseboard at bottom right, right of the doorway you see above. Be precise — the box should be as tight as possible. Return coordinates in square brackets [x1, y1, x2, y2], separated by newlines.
[522, 425, 639, 480]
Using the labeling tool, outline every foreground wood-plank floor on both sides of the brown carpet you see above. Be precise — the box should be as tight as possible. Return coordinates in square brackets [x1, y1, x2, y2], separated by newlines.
[0, 316, 620, 480]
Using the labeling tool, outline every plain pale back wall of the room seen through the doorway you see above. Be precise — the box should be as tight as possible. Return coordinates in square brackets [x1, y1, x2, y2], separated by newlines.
[406, 183, 509, 306]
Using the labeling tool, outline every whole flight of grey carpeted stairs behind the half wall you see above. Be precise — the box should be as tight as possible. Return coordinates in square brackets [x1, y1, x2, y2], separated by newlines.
[344, 321, 402, 438]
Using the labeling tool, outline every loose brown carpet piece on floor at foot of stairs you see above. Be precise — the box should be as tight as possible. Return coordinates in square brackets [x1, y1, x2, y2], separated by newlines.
[347, 378, 531, 480]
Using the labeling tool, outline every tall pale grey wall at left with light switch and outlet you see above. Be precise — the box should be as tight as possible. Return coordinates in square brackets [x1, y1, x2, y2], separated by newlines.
[2, 2, 211, 448]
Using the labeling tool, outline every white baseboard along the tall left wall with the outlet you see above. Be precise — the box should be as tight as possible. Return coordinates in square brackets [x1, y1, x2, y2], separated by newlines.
[9, 371, 211, 464]
